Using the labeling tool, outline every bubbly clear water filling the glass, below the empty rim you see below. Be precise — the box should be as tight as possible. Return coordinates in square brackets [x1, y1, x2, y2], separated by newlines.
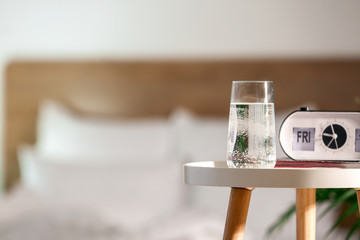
[227, 103, 276, 168]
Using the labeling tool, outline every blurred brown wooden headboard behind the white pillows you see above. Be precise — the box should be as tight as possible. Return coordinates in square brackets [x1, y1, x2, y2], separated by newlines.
[4, 60, 360, 188]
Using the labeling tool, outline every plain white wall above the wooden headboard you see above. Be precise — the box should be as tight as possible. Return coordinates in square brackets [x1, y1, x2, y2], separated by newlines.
[0, 0, 360, 58]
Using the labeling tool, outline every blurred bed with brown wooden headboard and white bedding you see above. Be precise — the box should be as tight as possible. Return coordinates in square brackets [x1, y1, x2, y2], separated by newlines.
[0, 60, 360, 239]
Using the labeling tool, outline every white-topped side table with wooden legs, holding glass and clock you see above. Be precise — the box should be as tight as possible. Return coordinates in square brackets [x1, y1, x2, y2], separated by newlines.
[184, 160, 360, 240]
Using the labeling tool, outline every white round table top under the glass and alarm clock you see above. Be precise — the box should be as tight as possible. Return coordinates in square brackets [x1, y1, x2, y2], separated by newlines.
[184, 160, 360, 188]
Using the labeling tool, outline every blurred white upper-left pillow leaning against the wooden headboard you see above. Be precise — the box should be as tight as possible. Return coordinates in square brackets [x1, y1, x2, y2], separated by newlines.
[37, 100, 172, 162]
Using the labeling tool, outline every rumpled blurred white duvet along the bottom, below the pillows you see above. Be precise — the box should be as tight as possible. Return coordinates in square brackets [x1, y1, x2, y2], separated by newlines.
[0, 186, 223, 240]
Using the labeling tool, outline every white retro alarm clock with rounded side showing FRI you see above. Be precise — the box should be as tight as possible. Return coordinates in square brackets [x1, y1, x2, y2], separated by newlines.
[279, 108, 360, 161]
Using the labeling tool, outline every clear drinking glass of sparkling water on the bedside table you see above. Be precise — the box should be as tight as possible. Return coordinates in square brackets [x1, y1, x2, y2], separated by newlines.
[227, 81, 276, 168]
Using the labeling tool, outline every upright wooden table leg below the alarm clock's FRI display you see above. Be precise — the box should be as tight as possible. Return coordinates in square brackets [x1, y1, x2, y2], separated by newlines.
[296, 188, 316, 240]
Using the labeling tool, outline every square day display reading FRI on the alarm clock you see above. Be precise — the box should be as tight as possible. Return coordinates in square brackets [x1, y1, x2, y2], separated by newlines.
[292, 128, 315, 151]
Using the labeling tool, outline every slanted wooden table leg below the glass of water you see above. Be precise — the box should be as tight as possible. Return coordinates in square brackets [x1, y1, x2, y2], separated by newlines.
[223, 188, 254, 240]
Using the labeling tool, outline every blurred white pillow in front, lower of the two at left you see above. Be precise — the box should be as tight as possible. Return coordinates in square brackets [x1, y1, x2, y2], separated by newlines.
[18, 146, 183, 230]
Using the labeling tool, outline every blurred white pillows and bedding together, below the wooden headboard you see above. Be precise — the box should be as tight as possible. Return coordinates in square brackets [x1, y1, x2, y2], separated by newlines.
[7, 102, 320, 240]
